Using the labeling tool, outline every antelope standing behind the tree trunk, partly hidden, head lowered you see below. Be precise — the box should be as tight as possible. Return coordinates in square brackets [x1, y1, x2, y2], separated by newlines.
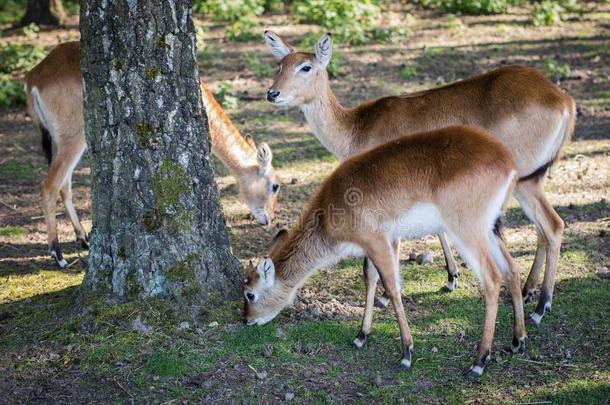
[25, 42, 280, 268]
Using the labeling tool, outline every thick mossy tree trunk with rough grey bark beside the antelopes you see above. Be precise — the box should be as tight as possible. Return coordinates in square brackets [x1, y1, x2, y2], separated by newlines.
[80, 0, 242, 304]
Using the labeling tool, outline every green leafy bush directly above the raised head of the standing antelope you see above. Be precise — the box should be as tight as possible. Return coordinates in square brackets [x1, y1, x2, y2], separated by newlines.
[292, 0, 381, 44]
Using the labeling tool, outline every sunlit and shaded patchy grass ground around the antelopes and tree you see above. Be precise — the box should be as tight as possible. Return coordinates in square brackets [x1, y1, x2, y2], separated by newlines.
[0, 3, 610, 404]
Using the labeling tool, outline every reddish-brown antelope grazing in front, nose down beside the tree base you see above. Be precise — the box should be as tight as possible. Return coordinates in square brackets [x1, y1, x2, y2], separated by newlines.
[244, 127, 526, 375]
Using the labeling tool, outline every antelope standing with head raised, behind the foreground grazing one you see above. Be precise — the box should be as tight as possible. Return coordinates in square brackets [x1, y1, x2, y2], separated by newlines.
[265, 31, 575, 325]
